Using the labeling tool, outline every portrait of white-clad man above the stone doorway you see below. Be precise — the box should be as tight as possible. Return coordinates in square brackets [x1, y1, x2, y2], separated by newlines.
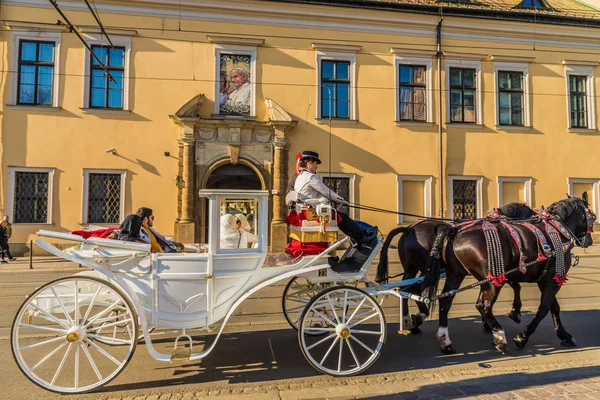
[219, 54, 252, 114]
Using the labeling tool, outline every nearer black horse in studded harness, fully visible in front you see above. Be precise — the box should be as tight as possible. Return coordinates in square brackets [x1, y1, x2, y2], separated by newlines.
[425, 193, 596, 354]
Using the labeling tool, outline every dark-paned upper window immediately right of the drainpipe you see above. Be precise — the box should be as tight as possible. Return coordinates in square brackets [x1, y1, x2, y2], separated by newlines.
[450, 68, 477, 123]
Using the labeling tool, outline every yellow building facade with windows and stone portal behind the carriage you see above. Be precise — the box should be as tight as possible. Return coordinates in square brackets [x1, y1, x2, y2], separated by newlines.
[0, 0, 600, 250]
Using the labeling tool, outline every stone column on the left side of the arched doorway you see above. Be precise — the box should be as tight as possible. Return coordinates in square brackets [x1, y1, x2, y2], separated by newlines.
[176, 130, 197, 243]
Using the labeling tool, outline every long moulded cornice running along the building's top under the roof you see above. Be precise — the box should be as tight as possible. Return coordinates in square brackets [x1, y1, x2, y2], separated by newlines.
[3, 0, 600, 49]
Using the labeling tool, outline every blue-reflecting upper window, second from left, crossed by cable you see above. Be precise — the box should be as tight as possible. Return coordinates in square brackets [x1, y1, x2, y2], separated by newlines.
[90, 45, 125, 109]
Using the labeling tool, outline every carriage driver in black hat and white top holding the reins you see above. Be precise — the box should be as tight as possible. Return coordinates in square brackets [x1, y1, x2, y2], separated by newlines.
[286, 151, 377, 255]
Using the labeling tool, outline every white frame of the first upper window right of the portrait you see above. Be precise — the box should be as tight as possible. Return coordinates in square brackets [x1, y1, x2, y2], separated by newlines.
[316, 50, 357, 121]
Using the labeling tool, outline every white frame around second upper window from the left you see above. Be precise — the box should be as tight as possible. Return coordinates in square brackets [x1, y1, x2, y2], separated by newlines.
[82, 33, 131, 113]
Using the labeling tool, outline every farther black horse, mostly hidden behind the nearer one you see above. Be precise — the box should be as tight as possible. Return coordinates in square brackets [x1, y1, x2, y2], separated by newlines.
[376, 203, 535, 333]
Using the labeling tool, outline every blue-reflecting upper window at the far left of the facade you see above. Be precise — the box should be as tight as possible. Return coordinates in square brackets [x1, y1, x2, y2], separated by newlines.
[17, 40, 54, 106]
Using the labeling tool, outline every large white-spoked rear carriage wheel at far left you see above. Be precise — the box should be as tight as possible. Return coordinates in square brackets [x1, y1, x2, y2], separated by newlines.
[11, 276, 139, 393]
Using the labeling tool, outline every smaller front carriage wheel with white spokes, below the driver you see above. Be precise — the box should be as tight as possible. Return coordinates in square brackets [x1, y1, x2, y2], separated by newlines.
[298, 286, 386, 376]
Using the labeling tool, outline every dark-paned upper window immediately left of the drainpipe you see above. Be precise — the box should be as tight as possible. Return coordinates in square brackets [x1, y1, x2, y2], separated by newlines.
[399, 65, 427, 121]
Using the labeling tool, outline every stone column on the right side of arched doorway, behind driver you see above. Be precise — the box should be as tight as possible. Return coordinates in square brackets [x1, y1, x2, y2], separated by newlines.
[271, 124, 288, 253]
